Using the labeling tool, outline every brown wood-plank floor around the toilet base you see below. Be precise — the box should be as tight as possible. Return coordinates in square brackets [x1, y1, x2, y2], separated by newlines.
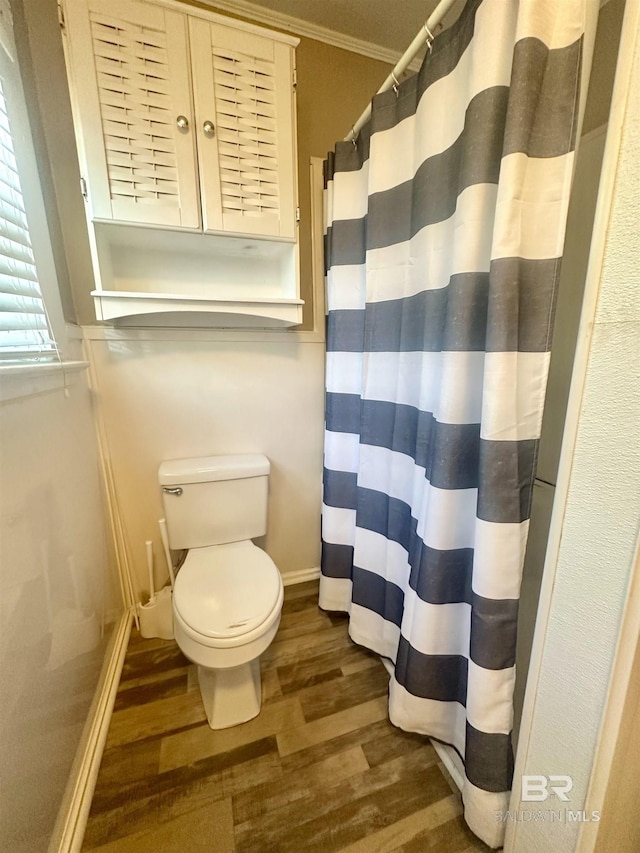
[82, 582, 489, 853]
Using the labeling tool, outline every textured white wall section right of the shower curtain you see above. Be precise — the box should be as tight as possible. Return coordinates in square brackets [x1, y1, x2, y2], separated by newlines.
[505, 13, 640, 853]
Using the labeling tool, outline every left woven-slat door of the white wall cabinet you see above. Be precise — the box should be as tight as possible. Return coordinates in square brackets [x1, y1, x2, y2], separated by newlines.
[65, 0, 200, 228]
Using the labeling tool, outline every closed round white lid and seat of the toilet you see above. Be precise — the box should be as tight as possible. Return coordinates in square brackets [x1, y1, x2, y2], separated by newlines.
[173, 540, 283, 648]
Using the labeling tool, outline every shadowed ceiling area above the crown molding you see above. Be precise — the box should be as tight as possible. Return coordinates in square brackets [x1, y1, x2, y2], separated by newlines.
[212, 0, 464, 57]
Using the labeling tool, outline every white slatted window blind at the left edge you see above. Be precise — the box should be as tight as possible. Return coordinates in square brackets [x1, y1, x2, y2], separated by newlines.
[0, 79, 57, 361]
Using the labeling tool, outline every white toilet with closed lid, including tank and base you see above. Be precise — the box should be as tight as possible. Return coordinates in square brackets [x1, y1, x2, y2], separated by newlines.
[158, 454, 284, 729]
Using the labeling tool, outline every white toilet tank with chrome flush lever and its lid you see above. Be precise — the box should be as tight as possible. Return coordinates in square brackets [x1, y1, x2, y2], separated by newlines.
[158, 453, 270, 550]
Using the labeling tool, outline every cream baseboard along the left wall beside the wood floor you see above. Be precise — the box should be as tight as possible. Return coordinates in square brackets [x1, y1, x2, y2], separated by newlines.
[49, 611, 131, 853]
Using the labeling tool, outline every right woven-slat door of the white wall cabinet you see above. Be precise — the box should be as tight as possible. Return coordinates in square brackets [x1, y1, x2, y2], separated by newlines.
[189, 18, 296, 240]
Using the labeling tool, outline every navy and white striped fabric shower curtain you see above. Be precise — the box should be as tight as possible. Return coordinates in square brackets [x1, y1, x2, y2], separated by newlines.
[320, 0, 585, 847]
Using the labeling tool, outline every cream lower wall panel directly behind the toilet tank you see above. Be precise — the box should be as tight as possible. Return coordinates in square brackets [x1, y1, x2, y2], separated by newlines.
[85, 327, 324, 593]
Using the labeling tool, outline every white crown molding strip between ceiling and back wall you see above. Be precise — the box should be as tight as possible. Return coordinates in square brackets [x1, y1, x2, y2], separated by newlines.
[200, 0, 421, 71]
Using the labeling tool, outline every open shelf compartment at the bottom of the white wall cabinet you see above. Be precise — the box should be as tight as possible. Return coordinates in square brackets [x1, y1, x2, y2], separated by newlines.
[92, 222, 304, 327]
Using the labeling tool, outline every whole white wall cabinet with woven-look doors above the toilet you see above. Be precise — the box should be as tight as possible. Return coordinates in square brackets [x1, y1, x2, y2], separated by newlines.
[63, 0, 302, 326]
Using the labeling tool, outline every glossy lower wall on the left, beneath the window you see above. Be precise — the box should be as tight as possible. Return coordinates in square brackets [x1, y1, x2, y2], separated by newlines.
[0, 344, 120, 853]
